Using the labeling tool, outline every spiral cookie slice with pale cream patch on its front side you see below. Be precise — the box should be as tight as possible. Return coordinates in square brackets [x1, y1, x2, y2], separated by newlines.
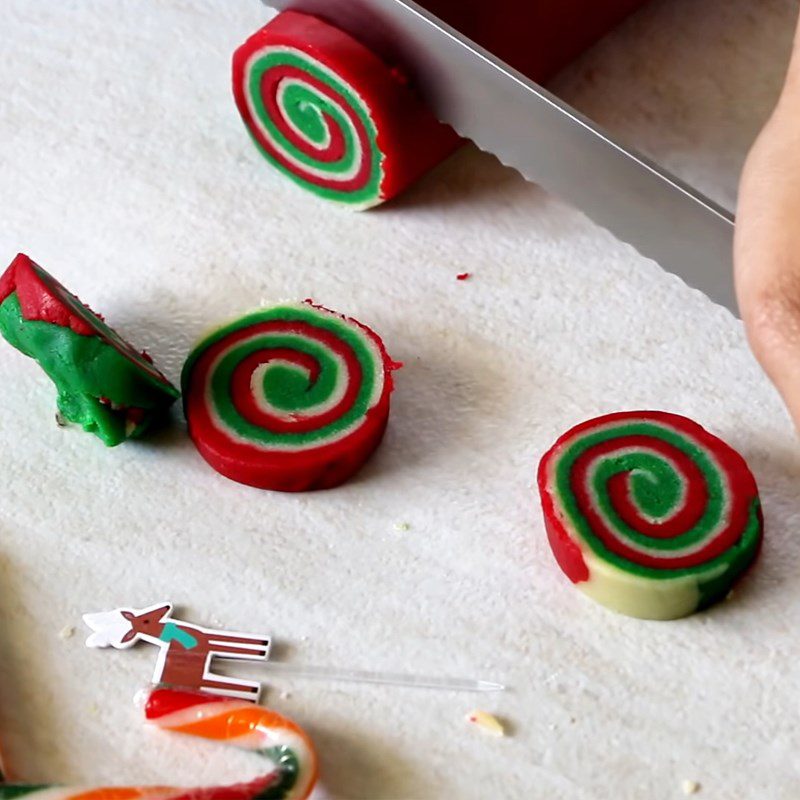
[539, 411, 763, 619]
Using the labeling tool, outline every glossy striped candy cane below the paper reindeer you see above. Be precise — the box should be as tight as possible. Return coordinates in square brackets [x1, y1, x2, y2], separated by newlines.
[0, 688, 317, 800]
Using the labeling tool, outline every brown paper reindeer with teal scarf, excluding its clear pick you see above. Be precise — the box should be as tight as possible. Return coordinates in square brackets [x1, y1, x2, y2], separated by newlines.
[83, 603, 270, 702]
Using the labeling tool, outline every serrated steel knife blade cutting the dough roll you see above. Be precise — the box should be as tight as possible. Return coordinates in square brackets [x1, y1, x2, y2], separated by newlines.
[265, 0, 737, 314]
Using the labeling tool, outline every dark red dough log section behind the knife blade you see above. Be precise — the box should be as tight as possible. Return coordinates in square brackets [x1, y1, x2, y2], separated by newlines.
[422, 0, 646, 83]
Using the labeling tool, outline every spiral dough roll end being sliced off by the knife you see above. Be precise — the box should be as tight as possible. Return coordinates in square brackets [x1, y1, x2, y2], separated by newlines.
[233, 11, 461, 209]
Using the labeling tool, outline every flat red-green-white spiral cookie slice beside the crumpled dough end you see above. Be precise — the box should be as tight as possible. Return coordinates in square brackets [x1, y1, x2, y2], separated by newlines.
[182, 303, 399, 492]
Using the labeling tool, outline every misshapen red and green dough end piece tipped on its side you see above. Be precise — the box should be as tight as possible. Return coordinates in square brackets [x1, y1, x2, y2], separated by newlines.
[0, 254, 179, 446]
